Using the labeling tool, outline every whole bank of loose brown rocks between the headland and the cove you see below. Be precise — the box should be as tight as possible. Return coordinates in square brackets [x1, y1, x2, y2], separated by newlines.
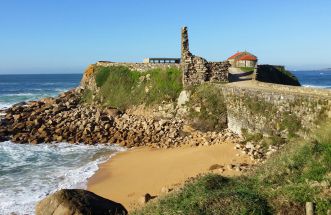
[0, 88, 239, 148]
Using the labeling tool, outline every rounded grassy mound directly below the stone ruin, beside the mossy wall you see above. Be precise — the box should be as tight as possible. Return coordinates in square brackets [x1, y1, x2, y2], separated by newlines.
[188, 84, 227, 131]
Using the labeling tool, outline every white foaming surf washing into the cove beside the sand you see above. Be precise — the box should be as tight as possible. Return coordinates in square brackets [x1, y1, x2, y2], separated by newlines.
[0, 141, 125, 214]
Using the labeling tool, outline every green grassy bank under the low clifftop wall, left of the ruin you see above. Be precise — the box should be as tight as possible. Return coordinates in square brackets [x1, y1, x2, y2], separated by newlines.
[95, 66, 182, 109]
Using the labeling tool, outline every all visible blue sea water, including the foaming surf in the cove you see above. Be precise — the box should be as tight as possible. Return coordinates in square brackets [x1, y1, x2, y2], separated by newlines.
[0, 71, 331, 215]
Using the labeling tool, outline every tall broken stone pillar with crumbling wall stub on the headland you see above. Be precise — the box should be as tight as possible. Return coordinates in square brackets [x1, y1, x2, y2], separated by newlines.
[181, 27, 231, 86]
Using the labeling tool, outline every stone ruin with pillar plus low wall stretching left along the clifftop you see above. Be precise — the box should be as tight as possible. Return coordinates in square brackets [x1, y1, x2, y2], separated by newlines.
[82, 27, 231, 86]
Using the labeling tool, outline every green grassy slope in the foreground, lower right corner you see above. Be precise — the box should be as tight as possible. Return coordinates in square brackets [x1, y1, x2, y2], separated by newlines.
[134, 123, 331, 214]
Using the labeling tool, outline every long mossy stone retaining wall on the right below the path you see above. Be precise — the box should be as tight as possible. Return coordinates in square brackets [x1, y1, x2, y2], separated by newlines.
[220, 82, 331, 137]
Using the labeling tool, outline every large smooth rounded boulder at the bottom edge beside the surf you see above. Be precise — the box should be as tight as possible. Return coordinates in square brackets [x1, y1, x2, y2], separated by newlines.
[36, 189, 128, 215]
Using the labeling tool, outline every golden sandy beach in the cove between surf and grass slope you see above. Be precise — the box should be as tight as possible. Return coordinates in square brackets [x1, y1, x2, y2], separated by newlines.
[88, 143, 252, 210]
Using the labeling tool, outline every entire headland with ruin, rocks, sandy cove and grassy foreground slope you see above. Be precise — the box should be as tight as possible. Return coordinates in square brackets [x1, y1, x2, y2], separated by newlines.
[0, 28, 331, 214]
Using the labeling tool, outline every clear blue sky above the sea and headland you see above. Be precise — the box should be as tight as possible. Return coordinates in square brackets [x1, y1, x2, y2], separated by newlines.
[0, 0, 331, 74]
